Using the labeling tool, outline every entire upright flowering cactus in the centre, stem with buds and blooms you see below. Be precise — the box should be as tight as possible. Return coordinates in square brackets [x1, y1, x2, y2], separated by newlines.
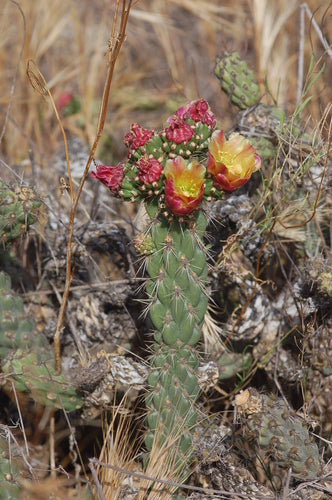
[91, 99, 261, 481]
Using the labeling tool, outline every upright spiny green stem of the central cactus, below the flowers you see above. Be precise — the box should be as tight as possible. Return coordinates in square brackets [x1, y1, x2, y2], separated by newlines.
[145, 203, 207, 473]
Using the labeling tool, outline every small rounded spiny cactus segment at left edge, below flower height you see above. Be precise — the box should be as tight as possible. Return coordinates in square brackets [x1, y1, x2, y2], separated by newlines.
[0, 181, 41, 244]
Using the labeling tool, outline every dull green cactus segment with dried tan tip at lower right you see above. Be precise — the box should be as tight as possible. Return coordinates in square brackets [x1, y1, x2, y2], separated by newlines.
[234, 389, 320, 480]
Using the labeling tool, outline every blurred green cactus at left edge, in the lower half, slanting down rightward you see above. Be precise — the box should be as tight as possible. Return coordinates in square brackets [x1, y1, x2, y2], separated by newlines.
[0, 273, 82, 411]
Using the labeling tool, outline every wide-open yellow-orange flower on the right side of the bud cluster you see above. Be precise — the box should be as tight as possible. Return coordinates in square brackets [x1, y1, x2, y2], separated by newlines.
[207, 130, 262, 193]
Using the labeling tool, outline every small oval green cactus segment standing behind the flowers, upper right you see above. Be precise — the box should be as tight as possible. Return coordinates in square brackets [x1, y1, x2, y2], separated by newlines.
[214, 52, 260, 109]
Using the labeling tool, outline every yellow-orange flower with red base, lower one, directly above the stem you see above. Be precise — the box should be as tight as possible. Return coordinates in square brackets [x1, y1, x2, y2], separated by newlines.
[164, 156, 205, 216]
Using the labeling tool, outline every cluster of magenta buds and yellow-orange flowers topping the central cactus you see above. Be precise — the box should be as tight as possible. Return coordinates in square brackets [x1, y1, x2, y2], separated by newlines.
[91, 99, 261, 217]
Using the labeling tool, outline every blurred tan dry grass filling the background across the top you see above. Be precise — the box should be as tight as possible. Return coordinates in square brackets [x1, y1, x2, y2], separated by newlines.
[0, 0, 332, 168]
